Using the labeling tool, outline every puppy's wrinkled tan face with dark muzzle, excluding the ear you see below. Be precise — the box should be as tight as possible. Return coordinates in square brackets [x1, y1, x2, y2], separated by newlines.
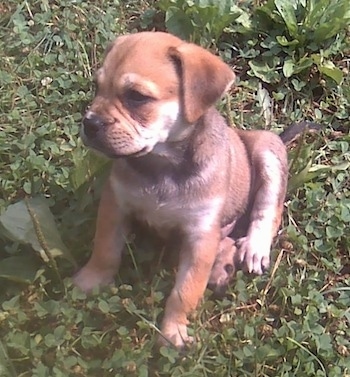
[81, 33, 187, 158]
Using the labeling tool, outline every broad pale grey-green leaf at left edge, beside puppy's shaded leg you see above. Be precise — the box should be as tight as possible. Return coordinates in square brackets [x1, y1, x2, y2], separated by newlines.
[0, 197, 75, 265]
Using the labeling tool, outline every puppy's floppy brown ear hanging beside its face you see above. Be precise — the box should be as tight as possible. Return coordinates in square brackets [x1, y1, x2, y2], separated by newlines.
[169, 43, 235, 123]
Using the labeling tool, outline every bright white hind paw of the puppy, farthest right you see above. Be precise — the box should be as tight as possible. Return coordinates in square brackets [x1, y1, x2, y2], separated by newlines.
[236, 236, 271, 275]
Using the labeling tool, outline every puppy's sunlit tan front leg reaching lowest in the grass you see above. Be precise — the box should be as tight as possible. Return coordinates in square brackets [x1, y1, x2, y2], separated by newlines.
[159, 231, 220, 348]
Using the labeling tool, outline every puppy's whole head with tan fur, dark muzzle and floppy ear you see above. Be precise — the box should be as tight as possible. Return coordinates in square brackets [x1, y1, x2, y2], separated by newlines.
[81, 32, 235, 158]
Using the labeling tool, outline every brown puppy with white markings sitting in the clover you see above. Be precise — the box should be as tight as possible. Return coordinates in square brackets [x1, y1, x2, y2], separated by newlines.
[75, 32, 287, 347]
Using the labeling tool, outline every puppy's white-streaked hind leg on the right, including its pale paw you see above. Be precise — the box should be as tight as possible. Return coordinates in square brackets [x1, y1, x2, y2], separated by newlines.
[236, 140, 288, 275]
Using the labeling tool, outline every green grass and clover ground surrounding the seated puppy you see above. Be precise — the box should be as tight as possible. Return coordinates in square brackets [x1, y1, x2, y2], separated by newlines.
[0, 0, 350, 377]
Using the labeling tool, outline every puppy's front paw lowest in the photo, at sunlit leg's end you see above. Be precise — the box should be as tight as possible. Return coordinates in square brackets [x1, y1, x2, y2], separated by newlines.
[157, 323, 194, 349]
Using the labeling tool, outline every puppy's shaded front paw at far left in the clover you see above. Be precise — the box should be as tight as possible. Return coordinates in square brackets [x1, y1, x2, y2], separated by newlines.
[73, 266, 114, 292]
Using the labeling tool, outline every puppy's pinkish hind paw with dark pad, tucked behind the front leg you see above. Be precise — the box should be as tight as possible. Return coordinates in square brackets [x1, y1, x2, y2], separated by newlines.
[208, 237, 237, 296]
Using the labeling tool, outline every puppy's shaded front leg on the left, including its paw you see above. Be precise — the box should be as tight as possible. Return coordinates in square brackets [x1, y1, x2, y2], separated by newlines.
[73, 179, 127, 291]
